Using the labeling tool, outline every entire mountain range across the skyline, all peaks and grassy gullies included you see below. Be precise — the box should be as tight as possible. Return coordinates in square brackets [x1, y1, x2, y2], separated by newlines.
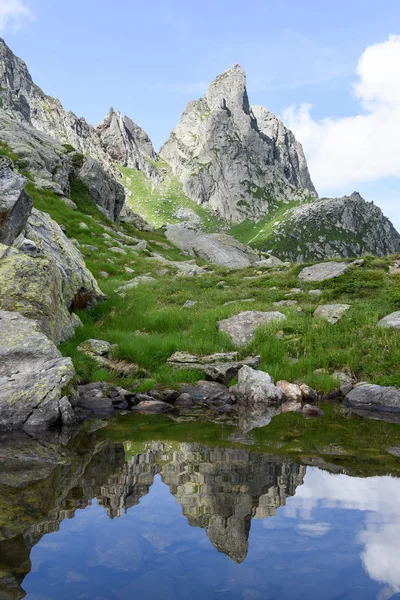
[0, 39, 400, 261]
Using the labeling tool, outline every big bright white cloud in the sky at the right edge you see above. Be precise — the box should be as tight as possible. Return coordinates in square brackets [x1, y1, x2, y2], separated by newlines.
[283, 35, 400, 193]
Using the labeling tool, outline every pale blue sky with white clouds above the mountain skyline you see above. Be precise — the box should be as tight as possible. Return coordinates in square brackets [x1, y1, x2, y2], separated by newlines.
[0, 0, 400, 230]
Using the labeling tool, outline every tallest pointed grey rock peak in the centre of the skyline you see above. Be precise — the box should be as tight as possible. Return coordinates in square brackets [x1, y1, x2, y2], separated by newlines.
[160, 65, 316, 222]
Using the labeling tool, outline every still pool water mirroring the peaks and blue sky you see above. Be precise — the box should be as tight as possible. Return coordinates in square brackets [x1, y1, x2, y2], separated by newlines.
[0, 426, 400, 600]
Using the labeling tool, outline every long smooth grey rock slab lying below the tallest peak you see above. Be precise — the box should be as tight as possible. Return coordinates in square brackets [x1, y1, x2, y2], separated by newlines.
[165, 224, 260, 269]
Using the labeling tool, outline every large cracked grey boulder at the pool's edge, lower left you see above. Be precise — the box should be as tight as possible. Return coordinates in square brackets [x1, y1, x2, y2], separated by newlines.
[0, 311, 74, 431]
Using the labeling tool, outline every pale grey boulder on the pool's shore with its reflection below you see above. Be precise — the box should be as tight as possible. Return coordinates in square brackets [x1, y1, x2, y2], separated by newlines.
[236, 366, 286, 431]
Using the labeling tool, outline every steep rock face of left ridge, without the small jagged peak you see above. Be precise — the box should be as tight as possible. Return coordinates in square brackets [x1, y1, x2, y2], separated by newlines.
[0, 39, 125, 220]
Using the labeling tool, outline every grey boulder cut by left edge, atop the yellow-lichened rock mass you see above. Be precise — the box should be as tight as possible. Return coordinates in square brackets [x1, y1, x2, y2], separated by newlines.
[0, 156, 33, 246]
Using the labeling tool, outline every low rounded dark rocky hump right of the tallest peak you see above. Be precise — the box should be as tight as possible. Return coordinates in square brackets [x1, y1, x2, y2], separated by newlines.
[266, 192, 400, 262]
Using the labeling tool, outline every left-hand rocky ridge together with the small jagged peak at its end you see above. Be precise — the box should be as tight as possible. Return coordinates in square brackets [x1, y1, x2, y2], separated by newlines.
[0, 39, 157, 220]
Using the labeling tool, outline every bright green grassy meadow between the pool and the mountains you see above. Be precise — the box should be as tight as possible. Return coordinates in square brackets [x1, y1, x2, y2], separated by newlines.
[28, 178, 400, 392]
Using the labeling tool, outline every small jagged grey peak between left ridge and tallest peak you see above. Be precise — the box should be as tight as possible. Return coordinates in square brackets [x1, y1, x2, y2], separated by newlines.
[96, 108, 158, 177]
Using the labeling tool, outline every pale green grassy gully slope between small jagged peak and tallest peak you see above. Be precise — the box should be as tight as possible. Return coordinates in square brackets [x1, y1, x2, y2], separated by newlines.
[120, 161, 224, 231]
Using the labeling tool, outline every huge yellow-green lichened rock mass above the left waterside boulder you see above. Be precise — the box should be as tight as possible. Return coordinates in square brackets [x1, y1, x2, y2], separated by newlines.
[0, 198, 105, 344]
